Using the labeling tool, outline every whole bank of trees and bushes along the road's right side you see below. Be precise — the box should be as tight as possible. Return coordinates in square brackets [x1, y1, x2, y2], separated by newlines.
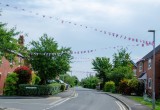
[81, 48, 144, 95]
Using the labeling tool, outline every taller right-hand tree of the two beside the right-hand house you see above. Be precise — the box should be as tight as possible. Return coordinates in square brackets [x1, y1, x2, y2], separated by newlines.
[110, 49, 133, 86]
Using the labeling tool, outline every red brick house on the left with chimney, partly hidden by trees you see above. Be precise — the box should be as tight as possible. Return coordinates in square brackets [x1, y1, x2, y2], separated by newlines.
[0, 36, 24, 94]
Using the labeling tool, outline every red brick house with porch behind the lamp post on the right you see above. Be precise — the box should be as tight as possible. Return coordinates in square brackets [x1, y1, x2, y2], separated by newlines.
[136, 45, 160, 98]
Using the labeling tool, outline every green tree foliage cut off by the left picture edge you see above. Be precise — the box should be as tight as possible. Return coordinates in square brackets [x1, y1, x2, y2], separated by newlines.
[0, 22, 21, 63]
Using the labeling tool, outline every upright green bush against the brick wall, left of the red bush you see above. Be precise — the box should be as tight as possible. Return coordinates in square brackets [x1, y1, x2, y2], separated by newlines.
[4, 73, 18, 96]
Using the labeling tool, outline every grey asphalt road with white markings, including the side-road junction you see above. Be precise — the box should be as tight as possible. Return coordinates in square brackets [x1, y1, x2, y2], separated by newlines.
[0, 87, 127, 110]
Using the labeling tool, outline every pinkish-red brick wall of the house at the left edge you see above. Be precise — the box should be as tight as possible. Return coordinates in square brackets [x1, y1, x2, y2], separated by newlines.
[0, 58, 23, 94]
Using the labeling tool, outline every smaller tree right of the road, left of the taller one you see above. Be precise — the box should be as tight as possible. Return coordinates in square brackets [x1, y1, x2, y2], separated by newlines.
[92, 57, 112, 85]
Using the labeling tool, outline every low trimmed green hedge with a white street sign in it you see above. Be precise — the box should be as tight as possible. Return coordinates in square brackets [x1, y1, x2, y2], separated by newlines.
[18, 84, 61, 96]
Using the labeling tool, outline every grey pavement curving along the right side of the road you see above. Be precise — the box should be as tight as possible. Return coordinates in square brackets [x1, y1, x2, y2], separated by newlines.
[107, 93, 151, 110]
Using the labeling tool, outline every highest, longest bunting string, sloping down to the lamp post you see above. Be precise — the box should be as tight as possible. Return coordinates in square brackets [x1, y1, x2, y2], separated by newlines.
[0, 3, 155, 46]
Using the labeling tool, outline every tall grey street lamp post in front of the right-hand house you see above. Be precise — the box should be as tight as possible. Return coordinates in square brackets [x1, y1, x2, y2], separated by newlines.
[148, 30, 155, 110]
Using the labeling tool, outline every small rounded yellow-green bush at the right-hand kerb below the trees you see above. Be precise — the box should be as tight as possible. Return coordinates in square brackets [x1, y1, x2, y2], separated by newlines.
[104, 81, 115, 92]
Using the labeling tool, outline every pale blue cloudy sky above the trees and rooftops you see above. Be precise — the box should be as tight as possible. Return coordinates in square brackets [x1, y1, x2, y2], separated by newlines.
[0, 0, 160, 79]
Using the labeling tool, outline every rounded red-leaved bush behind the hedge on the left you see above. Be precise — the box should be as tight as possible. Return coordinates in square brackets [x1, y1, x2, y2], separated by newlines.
[14, 66, 32, 84]
